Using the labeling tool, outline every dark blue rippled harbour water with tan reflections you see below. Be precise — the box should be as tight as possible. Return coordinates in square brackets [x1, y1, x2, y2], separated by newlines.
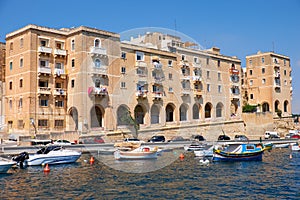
[0, 149, 300, 199]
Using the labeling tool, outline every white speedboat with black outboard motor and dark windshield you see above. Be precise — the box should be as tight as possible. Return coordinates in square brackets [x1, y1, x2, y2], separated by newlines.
[13, 145, 81, 166]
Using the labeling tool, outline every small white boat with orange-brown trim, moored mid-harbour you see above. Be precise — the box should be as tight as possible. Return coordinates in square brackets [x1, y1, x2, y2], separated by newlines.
[114, 144, 158, 160]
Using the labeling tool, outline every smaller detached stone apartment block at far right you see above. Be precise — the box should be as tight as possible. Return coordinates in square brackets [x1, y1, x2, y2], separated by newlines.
[244, 52, 292, 117]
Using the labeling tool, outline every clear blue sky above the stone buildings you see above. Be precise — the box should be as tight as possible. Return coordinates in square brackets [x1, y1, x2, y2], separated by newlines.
[0, 0, 300, 113]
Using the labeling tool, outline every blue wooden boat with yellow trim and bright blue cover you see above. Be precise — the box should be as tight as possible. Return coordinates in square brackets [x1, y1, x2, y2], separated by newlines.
[213, 143, 265, 161]
